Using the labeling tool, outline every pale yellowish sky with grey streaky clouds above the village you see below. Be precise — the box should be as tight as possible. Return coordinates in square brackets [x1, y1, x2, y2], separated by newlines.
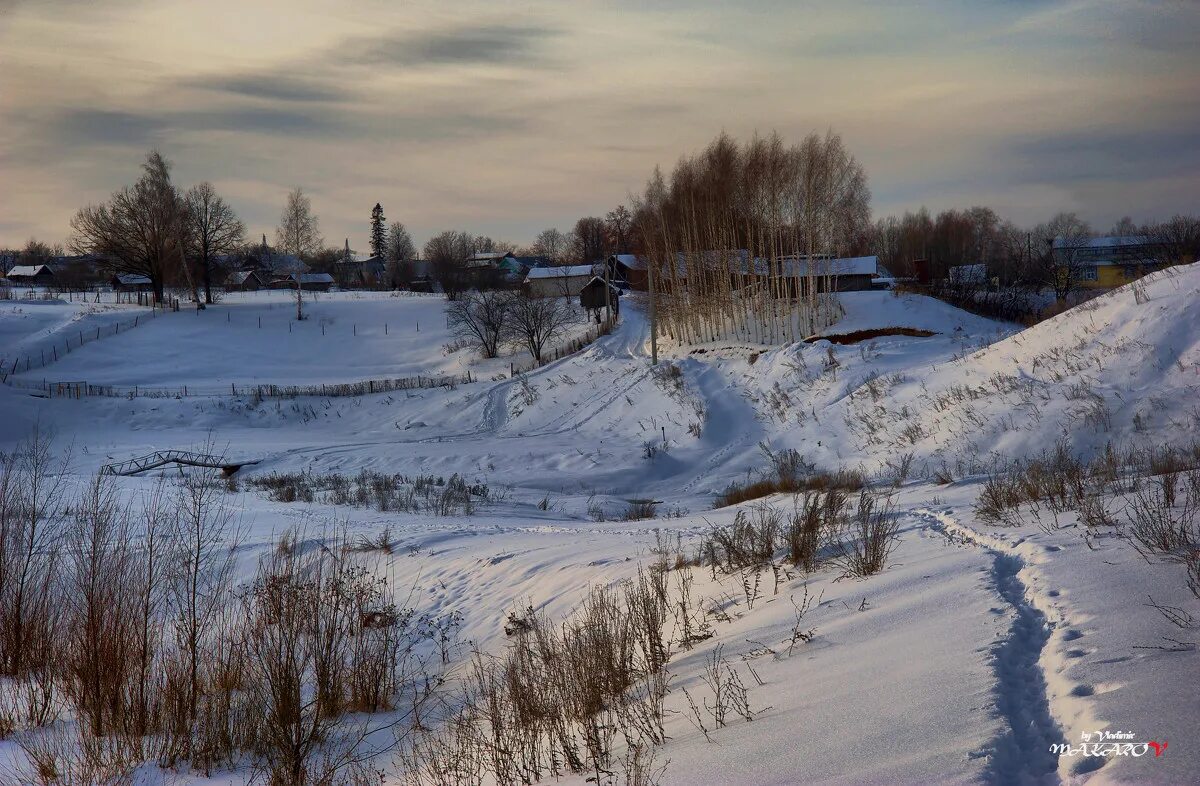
[0, 0, 1200, 248]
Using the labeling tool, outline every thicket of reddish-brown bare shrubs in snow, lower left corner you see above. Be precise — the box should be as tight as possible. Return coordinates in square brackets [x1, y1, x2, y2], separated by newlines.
[0, 433, 454, 786]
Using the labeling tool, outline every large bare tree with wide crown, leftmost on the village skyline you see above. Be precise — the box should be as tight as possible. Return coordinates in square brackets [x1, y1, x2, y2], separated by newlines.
[71, 150, 186, 300]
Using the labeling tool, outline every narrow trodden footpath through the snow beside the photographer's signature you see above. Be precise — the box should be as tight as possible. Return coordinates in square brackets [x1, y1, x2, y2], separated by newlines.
[916, 510, 1066, 784]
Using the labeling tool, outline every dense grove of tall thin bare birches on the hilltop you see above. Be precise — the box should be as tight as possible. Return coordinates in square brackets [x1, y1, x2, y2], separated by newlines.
[635, 132, 870, 344]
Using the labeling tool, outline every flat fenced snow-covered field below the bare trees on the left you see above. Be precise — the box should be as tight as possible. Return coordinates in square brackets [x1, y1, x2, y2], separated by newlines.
[0, 290, 587, 395]
